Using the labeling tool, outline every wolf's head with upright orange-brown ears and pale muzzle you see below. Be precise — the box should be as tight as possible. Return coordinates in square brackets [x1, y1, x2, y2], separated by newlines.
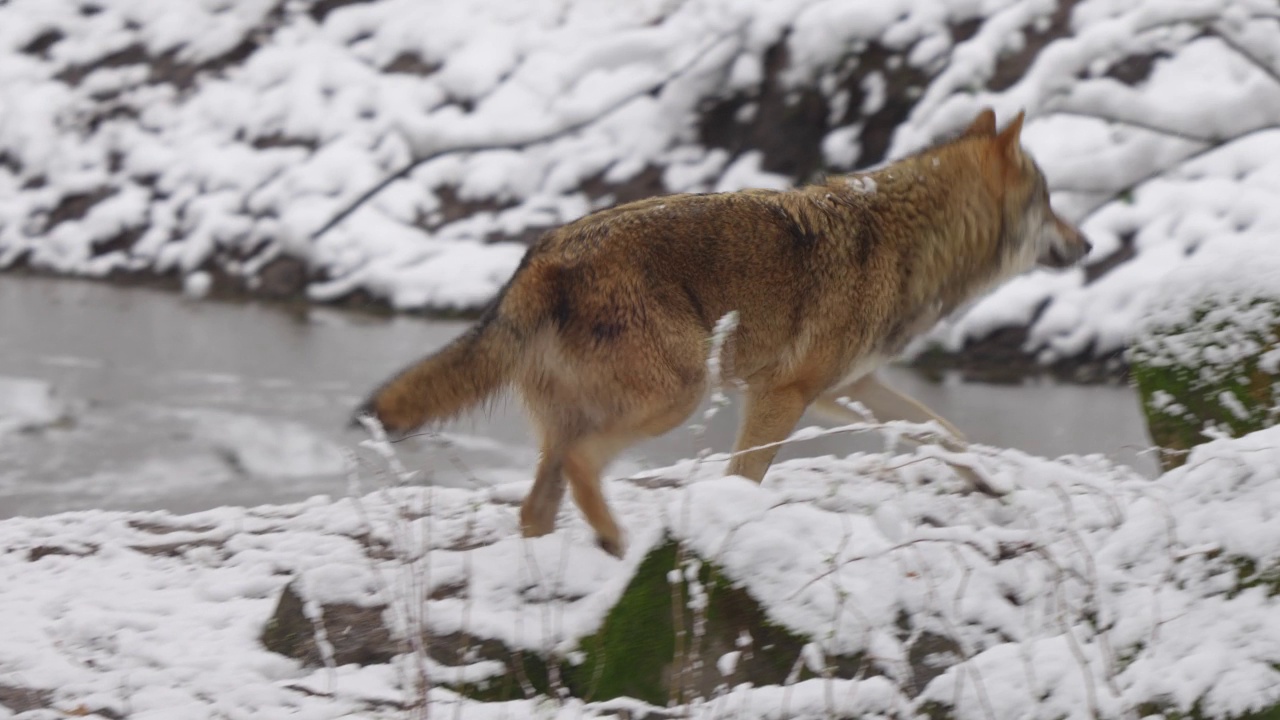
[961, 109, 1091, 268]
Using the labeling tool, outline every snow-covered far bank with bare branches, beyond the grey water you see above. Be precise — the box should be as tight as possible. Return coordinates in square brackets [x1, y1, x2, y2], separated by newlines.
[0, 0, 1280, 359]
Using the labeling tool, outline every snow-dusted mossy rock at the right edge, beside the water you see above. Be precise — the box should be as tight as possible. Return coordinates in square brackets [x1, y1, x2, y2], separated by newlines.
[1129, 284, 1280, 470]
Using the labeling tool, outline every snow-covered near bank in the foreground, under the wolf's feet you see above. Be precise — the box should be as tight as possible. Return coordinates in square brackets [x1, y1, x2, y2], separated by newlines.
[0, 417, 1280, 719]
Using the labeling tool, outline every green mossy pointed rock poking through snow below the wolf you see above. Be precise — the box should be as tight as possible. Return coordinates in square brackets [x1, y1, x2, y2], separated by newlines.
[450, 539, 861, 707]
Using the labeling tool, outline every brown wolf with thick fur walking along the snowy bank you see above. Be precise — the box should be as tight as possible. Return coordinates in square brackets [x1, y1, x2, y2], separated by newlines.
[364, 110, 1088, 552]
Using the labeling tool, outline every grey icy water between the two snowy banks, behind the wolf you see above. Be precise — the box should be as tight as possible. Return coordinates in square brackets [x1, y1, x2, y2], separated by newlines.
[0, 275, 1153, 518]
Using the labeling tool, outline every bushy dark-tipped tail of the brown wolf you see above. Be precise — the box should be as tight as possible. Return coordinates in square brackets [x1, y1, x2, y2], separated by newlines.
[356, 309, 521, 433]
